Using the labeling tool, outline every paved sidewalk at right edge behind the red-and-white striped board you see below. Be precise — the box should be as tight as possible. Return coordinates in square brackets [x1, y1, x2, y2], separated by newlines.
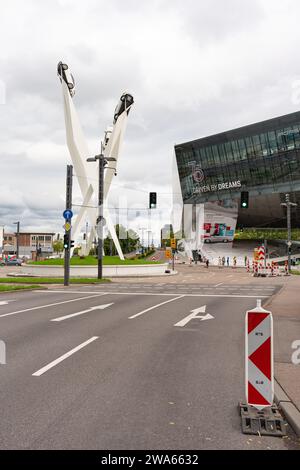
[265, 276, 300, 435]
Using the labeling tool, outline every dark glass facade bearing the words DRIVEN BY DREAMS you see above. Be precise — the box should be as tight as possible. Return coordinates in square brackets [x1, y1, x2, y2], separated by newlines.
[175, 112, 300, 225]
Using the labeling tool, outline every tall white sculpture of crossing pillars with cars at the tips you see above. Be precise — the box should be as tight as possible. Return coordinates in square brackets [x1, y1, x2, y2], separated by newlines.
[57, 62, 134, 259]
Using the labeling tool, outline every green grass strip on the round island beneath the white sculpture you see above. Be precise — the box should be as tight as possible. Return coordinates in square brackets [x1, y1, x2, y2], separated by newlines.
[28, 256, 161, 266]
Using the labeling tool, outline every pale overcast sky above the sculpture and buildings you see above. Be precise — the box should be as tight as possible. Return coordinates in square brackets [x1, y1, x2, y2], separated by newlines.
[0, 0, 300, 242]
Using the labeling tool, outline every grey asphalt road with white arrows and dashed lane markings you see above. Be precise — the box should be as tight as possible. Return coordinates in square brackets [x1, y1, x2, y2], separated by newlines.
[0, 283, 299, 450]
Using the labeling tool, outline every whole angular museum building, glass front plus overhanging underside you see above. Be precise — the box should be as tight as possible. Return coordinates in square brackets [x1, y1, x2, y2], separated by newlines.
[175, 112, 300, 241]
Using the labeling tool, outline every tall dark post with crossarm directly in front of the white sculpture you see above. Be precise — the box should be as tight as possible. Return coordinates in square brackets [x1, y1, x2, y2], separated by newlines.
[86, 142, 116, 279]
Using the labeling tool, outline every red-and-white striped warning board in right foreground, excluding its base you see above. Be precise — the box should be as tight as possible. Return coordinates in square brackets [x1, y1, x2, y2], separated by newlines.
[245, 300, 274, 410]
